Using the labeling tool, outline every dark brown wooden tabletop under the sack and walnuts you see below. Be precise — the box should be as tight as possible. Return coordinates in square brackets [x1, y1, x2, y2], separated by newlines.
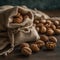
[0, 10, 60, 60]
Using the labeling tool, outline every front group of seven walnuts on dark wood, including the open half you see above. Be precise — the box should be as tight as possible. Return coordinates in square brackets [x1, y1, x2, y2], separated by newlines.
[20, 35, 57, 56]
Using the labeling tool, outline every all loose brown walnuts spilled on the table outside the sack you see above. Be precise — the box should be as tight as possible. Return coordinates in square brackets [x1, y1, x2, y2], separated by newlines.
[20, 16, 60, 56]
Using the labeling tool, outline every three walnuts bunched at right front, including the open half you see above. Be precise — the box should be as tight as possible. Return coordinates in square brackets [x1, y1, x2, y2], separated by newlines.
[40, 35, 57, 50]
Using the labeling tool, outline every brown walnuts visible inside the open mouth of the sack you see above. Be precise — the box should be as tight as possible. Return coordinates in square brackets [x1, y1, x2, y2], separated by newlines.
[12, 9, 30, 23]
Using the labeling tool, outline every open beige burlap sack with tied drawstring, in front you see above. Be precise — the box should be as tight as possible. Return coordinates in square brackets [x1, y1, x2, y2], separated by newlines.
[0, 6, 40, 55]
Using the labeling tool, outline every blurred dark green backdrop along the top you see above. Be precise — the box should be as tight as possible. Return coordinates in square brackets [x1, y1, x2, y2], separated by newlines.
[0, 0, 60, 10]
